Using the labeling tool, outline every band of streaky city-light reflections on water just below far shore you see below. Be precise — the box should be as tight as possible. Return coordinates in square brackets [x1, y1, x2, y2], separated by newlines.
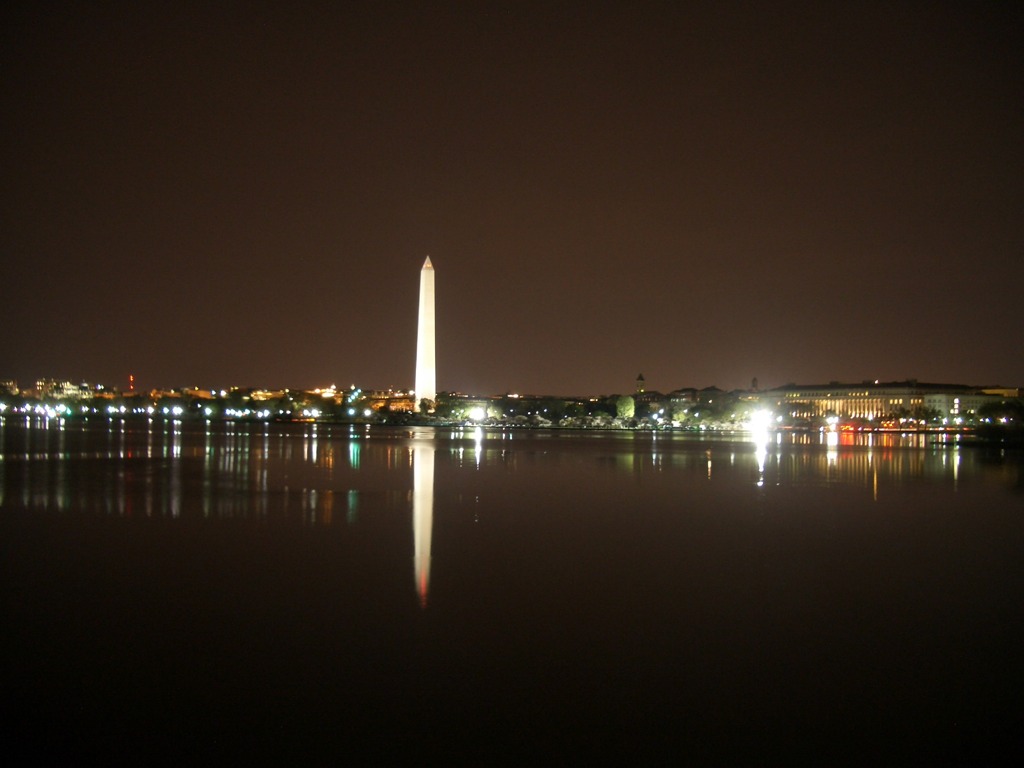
[0, 419, 1012, 525]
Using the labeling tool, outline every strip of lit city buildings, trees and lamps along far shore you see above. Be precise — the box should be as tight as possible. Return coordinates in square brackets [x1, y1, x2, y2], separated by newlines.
[0, 372, 1020, 438]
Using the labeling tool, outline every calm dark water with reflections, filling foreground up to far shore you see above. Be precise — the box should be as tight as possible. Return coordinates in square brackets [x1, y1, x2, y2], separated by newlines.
[0, 418, 1024, 765]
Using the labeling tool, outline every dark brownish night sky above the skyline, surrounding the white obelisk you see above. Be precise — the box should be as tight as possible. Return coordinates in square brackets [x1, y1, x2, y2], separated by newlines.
[0, 2, 1024, 395]
